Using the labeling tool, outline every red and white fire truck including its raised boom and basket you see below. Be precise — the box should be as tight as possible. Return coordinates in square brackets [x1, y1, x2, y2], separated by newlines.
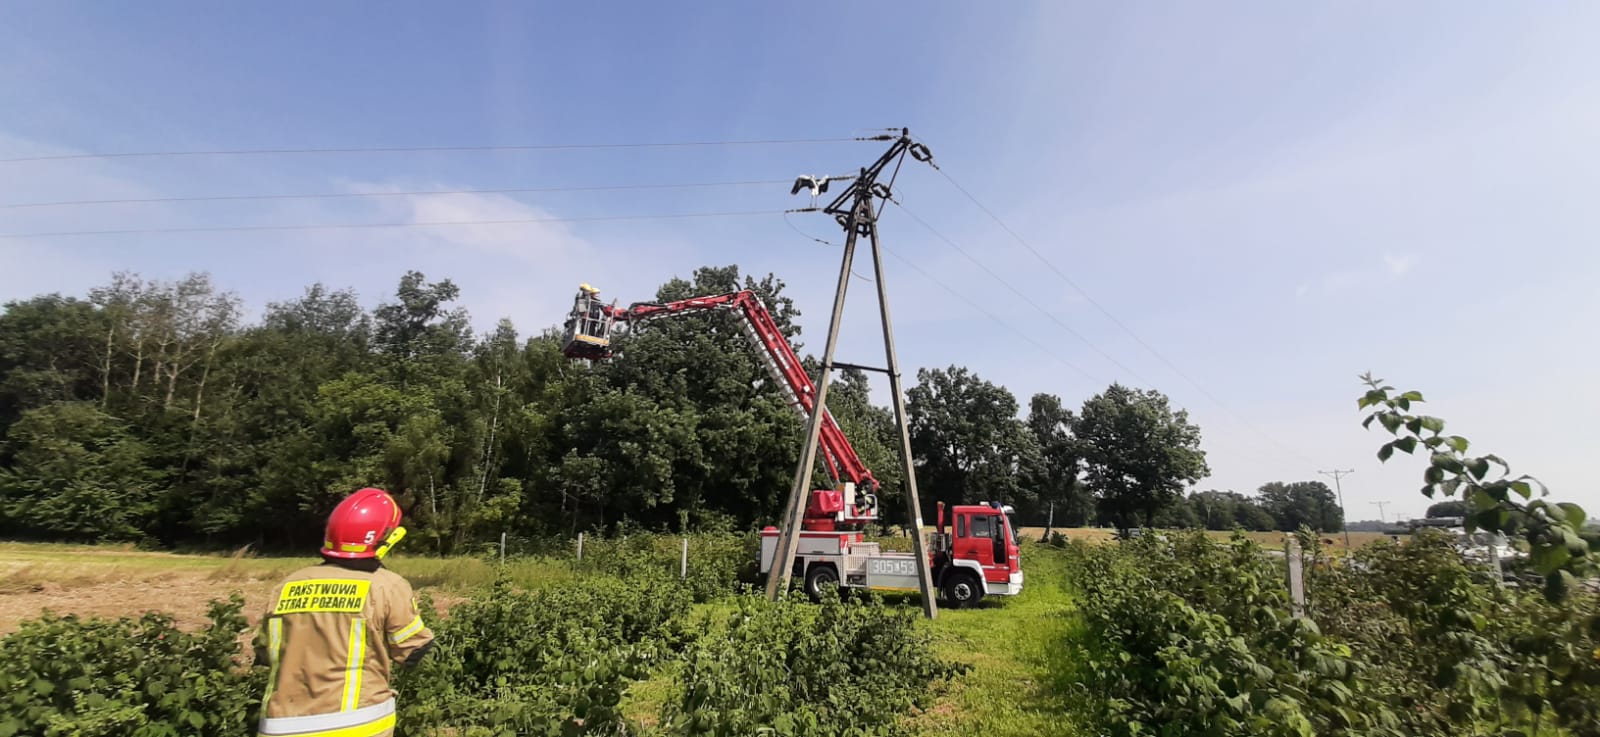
[562, 285, 1022, 608]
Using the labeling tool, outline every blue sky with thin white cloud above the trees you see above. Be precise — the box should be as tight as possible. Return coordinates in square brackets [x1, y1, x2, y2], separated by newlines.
[0, 2, 1600, 518]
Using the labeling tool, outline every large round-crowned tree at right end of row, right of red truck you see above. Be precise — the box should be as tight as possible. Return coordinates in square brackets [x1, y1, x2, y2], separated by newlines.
[1072, 384, 1210, 529]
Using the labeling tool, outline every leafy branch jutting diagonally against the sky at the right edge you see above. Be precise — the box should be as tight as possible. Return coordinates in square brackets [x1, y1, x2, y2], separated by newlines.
[1357, 372, 1600, 601]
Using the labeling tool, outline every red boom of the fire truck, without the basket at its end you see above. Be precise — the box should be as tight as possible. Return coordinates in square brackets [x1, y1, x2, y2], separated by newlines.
[603, 289, 878, 494]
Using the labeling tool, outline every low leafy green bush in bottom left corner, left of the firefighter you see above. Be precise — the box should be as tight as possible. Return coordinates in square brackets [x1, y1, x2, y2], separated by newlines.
[0, 593, 266, 737]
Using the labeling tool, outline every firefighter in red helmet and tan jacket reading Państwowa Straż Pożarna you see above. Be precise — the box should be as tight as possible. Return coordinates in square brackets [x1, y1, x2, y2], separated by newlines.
[256, 489, 434, 737]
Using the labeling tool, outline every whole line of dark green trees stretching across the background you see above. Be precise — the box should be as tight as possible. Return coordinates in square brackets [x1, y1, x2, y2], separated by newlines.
[0, 265, 1338, 553]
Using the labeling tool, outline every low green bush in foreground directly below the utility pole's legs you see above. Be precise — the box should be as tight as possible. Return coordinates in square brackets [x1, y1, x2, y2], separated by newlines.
[662, 593, 966, 737]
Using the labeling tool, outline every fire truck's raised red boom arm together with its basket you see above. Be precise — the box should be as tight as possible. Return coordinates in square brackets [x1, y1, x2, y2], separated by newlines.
[563, 285, 878, 505]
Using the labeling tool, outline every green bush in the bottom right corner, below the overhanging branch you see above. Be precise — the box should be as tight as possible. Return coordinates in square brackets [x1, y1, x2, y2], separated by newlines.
[1309, 532, 1600, 735]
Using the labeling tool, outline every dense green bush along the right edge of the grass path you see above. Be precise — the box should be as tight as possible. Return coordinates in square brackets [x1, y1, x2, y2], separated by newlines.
[1067, 532, 1395, 735]
